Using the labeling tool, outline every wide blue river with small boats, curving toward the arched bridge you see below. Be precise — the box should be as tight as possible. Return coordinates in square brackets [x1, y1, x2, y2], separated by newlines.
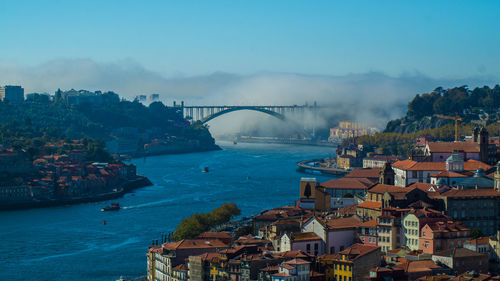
[0, 142, 334, 281]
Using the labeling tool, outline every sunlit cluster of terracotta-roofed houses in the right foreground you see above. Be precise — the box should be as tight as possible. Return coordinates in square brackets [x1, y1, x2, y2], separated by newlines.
[147, 130, 500, 281]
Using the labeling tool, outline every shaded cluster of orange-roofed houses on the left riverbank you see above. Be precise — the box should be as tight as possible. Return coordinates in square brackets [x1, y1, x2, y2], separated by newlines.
[0, 141, 136, 204]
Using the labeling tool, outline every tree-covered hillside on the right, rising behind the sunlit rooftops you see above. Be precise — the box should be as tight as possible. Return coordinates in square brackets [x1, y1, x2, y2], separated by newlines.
[342, 85, 500, 157]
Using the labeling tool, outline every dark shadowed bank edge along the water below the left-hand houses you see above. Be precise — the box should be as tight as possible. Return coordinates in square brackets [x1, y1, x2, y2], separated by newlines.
[0, 175, 153, 211]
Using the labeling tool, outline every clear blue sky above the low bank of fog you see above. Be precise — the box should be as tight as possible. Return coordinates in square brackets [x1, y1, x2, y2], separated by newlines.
[0, 0, 500, 78]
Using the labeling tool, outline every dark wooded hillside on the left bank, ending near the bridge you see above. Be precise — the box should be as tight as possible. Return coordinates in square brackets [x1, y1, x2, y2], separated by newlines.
[0, 95, 214, 158]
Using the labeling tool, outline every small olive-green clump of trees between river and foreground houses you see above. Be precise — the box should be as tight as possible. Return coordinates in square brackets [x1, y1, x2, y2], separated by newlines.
[173, 203, 241, 241]
